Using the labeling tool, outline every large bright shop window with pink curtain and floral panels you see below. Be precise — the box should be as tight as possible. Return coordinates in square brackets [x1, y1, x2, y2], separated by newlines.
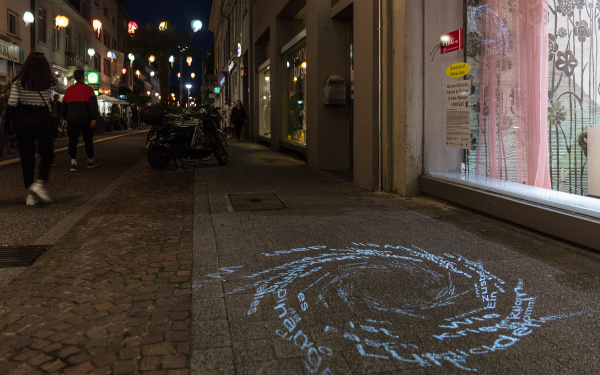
[465, 0, 600, 206]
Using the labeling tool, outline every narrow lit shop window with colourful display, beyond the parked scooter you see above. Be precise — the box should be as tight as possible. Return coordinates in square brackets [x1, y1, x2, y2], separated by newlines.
[282, 46, 306, 146]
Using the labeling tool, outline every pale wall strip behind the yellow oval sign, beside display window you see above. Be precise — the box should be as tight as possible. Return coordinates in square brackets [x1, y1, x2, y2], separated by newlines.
[423, 0, 464, 174]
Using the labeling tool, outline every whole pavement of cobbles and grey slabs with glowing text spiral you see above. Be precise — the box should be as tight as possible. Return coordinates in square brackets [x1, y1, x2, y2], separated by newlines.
[0, 142, 600, 374]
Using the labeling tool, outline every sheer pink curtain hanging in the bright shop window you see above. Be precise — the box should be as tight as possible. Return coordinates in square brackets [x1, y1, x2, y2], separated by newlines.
[477, 0, 551, 189]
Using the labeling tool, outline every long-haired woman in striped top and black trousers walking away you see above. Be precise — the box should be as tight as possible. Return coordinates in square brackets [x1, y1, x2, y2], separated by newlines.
[8, 52, 65, 206]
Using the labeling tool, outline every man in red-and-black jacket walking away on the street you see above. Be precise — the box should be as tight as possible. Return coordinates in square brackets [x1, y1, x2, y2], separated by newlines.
[63, 69, 100, 172]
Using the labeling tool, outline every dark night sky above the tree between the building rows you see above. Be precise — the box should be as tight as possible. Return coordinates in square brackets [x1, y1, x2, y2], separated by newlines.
[126, 0, 214, 87]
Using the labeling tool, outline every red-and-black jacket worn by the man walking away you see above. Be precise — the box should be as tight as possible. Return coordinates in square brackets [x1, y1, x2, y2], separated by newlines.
[62, 83, 100, 123]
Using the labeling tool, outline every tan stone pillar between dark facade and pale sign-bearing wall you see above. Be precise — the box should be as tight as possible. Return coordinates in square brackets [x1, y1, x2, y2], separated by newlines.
[382, 0, 423, 196]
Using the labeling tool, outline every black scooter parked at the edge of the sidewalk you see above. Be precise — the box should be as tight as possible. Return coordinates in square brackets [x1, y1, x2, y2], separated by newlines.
[140, 107, 229, 169]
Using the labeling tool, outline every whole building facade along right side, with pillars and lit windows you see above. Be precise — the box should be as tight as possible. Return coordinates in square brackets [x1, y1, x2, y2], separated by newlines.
[211, 0, 600, 253]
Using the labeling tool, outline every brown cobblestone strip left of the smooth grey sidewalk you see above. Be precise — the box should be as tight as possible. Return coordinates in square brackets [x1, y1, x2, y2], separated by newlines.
[0, 166, 194, 375]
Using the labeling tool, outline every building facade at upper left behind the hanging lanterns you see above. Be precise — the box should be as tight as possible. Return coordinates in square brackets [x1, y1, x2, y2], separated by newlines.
[0, 0, 129, 96]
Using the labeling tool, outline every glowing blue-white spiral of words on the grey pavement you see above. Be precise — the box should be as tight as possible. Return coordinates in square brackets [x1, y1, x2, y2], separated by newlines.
[194, 242, 583, 374]
